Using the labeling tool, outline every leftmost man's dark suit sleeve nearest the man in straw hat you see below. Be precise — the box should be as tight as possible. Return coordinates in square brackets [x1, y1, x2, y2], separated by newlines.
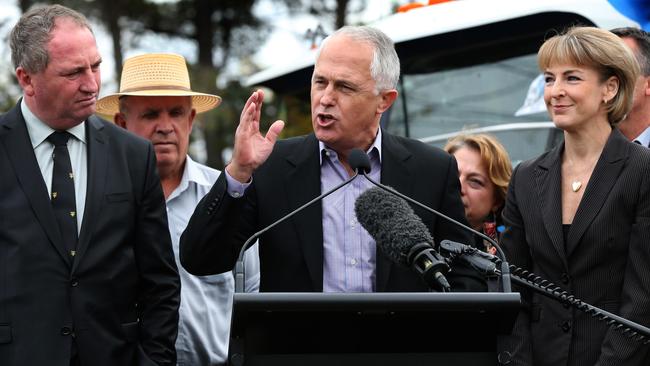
[134, 145, 180, 365]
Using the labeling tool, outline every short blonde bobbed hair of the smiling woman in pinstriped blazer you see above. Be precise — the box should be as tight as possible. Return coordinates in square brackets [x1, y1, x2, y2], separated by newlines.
[537, 27, 640, 125]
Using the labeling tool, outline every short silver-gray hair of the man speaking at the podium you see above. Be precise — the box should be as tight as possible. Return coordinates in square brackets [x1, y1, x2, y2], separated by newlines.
[316, 26, 400, 93]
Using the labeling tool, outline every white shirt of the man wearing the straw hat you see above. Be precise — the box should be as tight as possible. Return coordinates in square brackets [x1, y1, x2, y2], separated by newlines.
[167, 156, 260, 366]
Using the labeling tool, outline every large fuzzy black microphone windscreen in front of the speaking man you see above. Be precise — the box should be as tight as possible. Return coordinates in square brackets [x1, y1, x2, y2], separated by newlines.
[354, 187, 433, 266]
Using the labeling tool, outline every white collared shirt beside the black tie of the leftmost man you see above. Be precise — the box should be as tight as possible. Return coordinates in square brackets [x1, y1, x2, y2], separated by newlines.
[20, 99, 88, 235]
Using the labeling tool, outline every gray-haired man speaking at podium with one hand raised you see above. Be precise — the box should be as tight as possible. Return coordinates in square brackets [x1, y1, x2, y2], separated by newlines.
[181, 27, 485, 292]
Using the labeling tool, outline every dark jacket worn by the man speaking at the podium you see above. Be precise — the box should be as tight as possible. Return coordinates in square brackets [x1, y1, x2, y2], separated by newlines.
[180, 132, 485, 292]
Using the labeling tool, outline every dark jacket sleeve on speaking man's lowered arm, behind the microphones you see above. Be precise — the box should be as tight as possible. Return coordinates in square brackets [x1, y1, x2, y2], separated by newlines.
[434, 156, 487, 292]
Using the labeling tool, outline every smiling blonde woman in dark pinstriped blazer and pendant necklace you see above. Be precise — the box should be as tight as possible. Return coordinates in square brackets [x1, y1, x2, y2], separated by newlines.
[499, 27, 650, 366]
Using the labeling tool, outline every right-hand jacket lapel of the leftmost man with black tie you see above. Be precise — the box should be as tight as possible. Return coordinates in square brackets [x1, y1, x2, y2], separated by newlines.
[72, 116, 108, 272]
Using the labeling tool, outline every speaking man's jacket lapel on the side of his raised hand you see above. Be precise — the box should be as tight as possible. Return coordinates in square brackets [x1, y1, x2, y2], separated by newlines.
[285, 134, 323, 292]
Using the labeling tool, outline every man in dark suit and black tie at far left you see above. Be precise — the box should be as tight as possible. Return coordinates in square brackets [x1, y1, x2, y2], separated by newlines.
[0, 5, 179, 366]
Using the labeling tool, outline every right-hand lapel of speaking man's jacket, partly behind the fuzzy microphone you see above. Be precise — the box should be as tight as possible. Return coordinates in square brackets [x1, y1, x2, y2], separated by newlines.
[376, 130, 413, 292]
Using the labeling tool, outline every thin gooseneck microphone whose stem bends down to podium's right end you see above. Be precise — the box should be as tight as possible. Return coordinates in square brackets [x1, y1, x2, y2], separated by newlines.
[350, 149, 512, 292]
